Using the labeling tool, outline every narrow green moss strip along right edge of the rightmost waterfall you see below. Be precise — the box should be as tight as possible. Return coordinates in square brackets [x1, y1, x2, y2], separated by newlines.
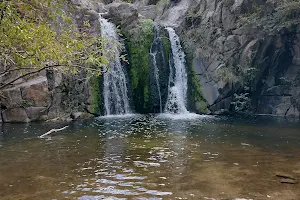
[185, 47, 207, 113]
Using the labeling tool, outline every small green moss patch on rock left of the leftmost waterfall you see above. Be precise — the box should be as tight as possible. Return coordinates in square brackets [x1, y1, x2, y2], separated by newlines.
[90, 76, 101, 113]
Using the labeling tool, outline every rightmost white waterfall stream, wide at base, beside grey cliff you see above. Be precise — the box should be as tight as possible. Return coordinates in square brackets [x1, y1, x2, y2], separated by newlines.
[165, 27, 188, 114]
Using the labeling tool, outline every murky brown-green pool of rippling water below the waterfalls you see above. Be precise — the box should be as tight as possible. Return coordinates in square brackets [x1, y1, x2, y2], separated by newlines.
[0, 115, 300, 200]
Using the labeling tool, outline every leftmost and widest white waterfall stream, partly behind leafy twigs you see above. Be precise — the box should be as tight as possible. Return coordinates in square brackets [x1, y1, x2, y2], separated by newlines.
[99, 16, 130, 115]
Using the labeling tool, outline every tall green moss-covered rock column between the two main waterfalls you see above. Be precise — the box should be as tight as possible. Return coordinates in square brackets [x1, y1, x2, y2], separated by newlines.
[126, 19, 154, 112]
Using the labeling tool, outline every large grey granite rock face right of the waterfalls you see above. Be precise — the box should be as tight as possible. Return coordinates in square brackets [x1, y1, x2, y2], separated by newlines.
[178, 0, 300, 117]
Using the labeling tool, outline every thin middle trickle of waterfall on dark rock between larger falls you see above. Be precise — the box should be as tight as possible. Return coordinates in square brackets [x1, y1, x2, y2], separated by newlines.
[150, 26, 163, 113]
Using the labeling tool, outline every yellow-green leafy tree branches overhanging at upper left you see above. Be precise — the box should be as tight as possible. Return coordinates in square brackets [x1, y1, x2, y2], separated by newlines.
[0, 0, 108, 90]
